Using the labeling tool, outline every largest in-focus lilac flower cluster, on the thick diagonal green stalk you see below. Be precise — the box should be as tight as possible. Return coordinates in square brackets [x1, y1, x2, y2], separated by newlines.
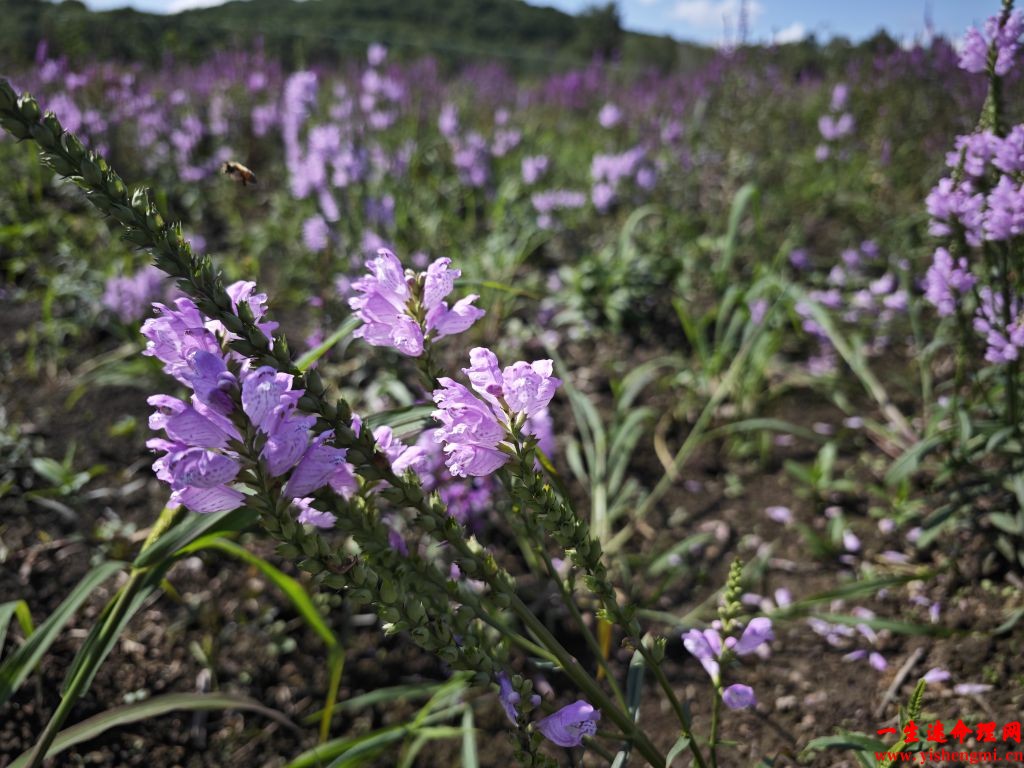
[142, 283, 352, 526]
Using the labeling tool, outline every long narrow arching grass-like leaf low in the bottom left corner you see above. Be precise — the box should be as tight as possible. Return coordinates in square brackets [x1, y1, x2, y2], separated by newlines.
[9, 693, 298, 768]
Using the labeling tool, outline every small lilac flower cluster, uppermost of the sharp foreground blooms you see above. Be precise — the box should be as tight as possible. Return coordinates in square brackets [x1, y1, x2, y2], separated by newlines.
[348, 248, 484, 357]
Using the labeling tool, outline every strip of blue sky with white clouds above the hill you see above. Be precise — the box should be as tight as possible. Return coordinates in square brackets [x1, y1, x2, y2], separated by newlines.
[79, 0, 999, 44]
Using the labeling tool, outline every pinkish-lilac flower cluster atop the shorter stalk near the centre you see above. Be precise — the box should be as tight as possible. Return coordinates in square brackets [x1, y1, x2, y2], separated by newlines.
[433, 347, 561, 477]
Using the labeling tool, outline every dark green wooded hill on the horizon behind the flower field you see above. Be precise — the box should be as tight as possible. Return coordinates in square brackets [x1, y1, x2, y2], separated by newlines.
[0, 0, 711, 72]
